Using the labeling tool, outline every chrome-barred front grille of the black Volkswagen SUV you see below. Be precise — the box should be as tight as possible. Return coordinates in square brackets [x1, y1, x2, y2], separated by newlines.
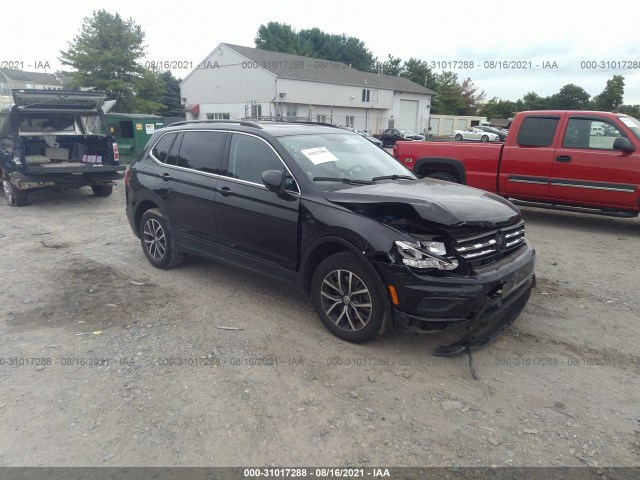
[454, 222, 524, 261]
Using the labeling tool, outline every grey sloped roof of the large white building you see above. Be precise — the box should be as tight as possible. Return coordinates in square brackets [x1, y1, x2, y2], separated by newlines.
[222, 43, 435, 95]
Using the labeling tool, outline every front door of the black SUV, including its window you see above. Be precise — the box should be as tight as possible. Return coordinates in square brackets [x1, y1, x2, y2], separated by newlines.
[216, 133, 300, 281]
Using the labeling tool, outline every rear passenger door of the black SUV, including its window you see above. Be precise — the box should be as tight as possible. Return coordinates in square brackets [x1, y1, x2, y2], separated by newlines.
[157, 127, 227, 257]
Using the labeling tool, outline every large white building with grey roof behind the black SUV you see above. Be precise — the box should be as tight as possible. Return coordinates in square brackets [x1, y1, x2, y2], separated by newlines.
[180, 43, 434, 133]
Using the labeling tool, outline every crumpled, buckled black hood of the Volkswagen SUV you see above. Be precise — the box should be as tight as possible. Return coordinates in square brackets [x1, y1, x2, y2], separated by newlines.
[323, 178, 520, 227]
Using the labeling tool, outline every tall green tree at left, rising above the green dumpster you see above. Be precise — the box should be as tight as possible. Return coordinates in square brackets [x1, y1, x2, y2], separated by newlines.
[59, 10, 145, 112]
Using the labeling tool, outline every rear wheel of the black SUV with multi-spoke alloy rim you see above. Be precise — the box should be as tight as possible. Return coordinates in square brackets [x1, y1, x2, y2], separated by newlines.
[140, 208, 184, 269]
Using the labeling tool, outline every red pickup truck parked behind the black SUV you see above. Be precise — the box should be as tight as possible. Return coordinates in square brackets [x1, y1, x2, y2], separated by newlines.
[393, 110, 640, 217]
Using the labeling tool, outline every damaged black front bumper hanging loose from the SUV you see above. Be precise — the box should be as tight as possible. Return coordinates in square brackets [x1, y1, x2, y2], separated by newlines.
[375, 240, 535, 356]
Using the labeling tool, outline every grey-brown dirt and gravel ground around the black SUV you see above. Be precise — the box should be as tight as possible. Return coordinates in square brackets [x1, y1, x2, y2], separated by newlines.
[0, 183, 640, 468]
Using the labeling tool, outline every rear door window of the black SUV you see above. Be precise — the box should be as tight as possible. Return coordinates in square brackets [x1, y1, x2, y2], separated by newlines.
[176, 132, 226, 174]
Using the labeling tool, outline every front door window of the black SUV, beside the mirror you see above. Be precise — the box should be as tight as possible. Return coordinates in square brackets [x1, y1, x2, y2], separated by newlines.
[227, 134, 284, 185]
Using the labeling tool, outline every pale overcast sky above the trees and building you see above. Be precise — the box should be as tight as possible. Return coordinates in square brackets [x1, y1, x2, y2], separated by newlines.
[5, 0, 640, 104]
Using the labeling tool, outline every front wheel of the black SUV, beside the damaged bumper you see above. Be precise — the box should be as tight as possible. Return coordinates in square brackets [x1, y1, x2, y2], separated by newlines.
[311, 252, 387, 343]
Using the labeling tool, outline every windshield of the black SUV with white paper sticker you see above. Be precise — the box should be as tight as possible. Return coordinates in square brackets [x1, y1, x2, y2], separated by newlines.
[278, 133, 415, 188]
